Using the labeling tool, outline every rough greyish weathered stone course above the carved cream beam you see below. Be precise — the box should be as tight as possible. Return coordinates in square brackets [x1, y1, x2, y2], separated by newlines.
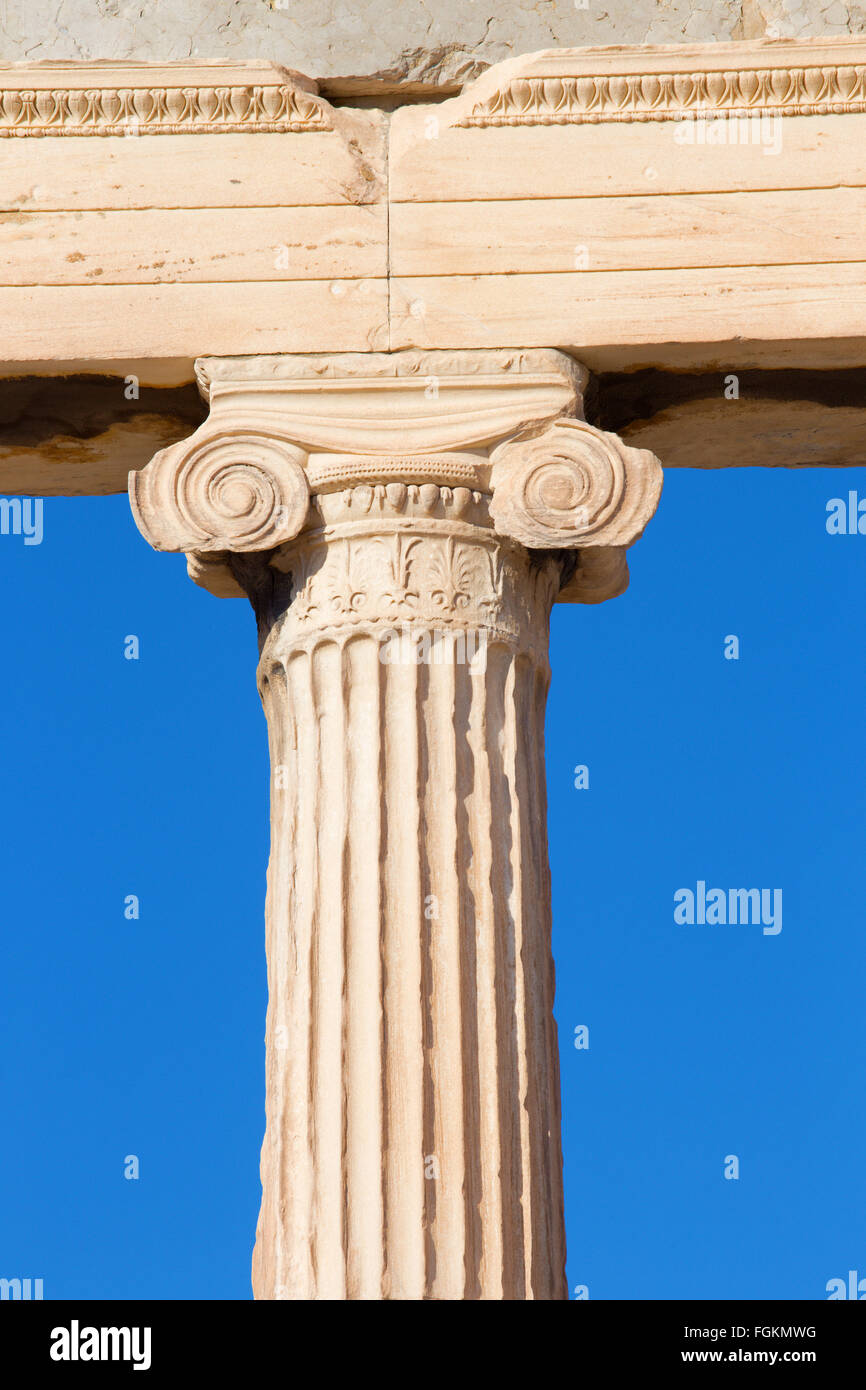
[0, 0, 866, 86]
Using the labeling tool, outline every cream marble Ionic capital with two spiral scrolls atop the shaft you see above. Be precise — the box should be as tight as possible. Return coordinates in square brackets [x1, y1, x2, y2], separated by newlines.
[129, 350, 662, 602]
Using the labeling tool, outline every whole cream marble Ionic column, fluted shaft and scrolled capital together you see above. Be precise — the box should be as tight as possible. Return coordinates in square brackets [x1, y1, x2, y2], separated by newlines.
[129, 350, 662, 1300]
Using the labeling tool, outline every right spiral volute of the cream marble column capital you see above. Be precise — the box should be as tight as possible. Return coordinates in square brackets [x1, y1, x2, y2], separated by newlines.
[491, 420, 662, 549]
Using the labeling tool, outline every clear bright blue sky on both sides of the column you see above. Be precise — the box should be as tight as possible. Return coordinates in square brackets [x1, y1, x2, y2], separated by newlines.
[0, 468, 866, 1298]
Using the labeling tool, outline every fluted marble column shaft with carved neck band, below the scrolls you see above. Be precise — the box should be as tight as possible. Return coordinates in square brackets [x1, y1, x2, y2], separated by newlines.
[247, 485, 564, 1300]
